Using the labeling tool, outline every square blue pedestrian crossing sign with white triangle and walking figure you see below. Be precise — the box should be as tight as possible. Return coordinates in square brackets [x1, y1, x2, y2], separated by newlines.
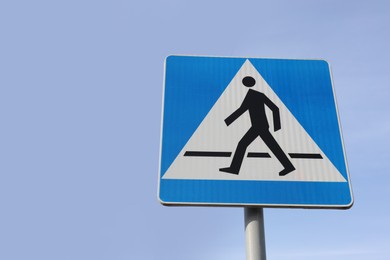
[159, 56, 353, 208]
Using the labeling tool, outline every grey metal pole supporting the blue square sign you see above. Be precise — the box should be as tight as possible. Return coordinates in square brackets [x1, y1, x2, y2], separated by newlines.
[244, 208, 266, 260]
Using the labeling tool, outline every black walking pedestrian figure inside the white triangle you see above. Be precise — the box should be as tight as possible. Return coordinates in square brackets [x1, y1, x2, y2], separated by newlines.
[219, 76, 295, 176]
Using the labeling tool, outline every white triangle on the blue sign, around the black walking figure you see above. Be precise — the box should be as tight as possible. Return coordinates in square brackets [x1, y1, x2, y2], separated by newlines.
[163, 60, 346, 182]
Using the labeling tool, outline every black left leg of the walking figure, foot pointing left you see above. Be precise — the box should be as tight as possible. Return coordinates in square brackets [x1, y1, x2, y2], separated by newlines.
[219, 128, 259, 174]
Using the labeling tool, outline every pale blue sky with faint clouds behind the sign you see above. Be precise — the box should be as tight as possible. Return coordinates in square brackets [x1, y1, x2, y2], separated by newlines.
[0, 0, 390, 260]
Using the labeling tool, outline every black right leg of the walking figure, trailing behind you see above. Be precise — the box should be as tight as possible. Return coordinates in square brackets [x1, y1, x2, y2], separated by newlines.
[260, 130, 295, 176]
